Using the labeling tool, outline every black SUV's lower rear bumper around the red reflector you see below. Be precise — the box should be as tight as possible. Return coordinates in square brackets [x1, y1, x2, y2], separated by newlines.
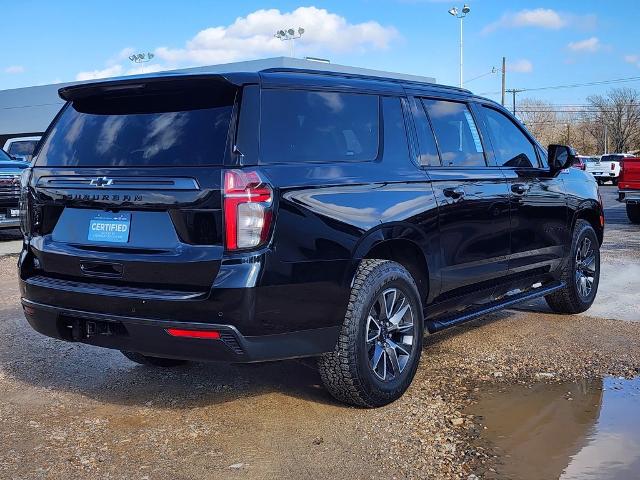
[22, 298, 339, 363]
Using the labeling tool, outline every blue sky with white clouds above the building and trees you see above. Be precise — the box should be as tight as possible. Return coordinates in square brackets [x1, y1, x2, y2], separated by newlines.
[0, 0, 640, 103]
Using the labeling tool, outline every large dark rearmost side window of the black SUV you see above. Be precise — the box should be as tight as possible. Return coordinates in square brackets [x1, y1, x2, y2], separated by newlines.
[260, 90, 380, 163]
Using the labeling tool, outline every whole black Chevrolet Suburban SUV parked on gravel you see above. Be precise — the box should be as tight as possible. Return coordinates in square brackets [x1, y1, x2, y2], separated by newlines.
[19, 69, 604, 407]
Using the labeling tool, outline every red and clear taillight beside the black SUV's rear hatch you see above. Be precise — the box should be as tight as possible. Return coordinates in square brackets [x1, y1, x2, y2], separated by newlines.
[224, 170, 273, 250]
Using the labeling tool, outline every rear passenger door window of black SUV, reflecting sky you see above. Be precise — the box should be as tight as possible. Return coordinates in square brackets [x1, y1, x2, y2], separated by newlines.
[422, 99, 486, 167]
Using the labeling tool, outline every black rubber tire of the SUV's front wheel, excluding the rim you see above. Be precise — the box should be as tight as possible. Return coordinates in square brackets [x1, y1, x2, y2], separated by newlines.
[545, 220, 600, 314]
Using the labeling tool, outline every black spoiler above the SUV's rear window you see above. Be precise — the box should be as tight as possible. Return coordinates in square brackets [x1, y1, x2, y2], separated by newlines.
[58, 72, 259, 101]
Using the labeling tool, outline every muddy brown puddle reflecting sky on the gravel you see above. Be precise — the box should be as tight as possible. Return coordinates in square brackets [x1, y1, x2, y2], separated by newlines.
[471, 377, 640, 480]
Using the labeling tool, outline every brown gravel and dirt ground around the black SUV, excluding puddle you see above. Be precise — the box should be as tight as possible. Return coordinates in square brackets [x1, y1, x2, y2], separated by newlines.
[0, 187, 640, 479]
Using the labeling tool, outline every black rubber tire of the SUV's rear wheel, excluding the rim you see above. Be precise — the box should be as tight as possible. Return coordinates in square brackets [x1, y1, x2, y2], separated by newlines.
[318, 259, 424, 408]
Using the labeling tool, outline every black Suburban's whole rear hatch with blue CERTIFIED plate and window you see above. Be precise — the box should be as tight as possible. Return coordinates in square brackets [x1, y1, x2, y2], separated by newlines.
[23, 76, 238, 299]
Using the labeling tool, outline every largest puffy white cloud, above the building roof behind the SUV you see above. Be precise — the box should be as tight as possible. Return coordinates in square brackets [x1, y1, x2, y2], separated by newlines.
[76, 7, 400, 80]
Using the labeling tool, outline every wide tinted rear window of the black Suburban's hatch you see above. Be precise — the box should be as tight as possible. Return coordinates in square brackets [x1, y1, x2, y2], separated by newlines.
[37, 87, 234, 167]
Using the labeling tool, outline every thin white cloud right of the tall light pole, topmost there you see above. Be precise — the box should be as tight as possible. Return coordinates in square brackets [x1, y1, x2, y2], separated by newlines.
[482, 8, 596, 33]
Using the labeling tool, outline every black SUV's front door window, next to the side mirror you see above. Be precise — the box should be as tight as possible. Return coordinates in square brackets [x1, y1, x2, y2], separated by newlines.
[482, 106, 538, 168]
